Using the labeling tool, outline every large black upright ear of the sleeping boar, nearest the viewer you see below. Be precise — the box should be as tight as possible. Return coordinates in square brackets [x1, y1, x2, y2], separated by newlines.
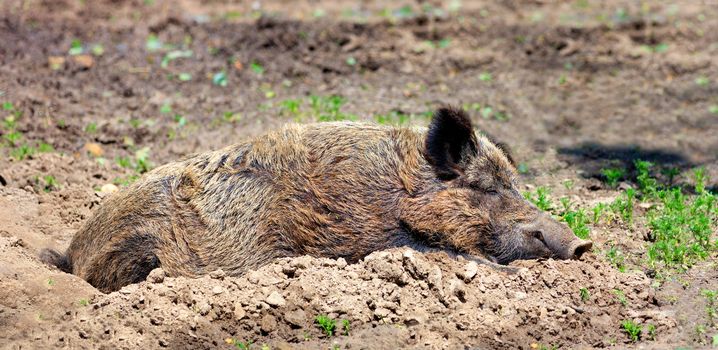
[425, 107, 477, 180]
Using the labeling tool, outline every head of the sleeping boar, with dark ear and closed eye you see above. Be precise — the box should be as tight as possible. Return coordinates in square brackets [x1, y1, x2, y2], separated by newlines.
[401, 108, 592, 264]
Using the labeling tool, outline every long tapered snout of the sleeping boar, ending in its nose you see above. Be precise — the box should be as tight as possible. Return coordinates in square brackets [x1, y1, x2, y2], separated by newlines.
[525, 213, 593, 259]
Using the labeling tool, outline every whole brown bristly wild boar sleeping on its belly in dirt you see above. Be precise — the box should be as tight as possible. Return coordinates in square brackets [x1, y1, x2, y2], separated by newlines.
[41, 108, 590, 291]
